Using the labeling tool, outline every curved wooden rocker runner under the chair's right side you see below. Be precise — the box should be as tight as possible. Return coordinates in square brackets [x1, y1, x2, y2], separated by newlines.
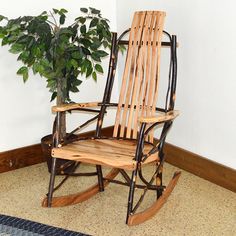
[128, 171, 181, 226]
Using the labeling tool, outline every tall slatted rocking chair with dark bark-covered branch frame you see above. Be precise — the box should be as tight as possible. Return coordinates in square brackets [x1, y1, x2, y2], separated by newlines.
[43, 11, 180, 225]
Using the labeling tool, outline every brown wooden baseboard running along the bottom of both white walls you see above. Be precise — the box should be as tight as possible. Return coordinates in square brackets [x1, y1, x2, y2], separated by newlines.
[0, 126, 236, 192]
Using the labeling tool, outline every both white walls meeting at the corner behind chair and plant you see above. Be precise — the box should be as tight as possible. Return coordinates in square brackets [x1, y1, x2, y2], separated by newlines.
[0, 0, 236, 168]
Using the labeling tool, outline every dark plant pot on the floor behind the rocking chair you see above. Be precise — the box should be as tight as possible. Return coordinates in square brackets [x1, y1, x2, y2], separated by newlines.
[41, 135, 77, 175]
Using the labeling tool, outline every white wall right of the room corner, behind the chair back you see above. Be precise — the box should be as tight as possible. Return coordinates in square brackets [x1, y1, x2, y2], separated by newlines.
[117, 0, 236, 168]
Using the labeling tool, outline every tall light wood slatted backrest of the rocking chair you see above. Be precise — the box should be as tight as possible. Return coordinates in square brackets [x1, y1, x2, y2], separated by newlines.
[113, 11, 165, 139]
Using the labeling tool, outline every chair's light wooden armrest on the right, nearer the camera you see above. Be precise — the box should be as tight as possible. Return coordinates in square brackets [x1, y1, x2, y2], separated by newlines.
[139, 110, 179, 123]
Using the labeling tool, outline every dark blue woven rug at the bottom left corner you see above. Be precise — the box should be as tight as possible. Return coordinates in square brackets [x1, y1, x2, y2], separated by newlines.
[0, 214, 88, 236]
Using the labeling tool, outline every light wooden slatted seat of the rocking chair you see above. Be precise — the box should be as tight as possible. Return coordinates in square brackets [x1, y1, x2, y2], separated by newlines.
[52, 139, 159, 170]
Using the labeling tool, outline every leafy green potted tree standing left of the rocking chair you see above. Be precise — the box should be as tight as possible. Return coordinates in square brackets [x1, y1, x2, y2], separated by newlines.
[0, 7, 111, 173]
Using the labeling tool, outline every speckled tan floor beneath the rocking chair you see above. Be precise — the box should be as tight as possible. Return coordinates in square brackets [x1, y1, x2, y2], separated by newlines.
[0, 164, 236, 236]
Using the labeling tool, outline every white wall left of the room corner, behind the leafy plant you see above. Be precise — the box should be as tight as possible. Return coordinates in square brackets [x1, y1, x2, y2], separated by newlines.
[0, 0, 116, 152]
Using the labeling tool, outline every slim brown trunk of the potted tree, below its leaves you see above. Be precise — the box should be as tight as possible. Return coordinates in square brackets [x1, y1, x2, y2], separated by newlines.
[57, 78, 66, 139]
